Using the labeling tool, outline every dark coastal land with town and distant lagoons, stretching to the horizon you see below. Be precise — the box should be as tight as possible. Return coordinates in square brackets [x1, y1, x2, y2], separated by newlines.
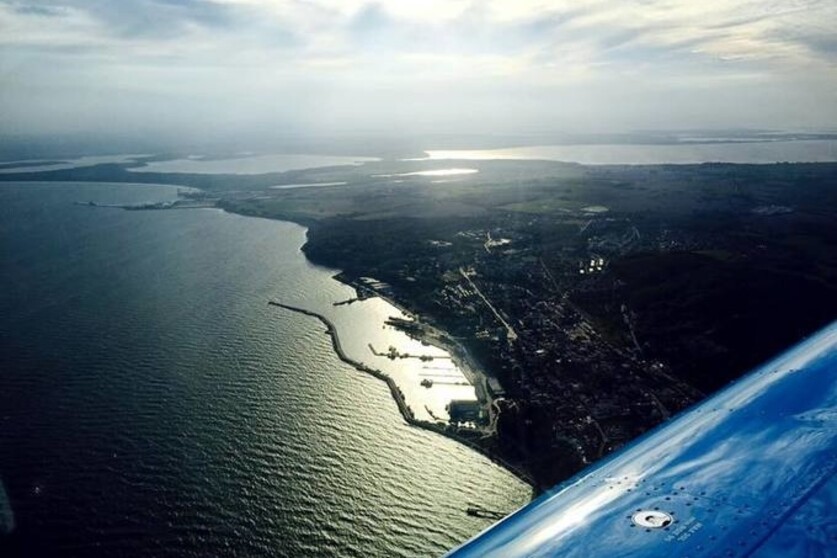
[0, 157, 837, 489]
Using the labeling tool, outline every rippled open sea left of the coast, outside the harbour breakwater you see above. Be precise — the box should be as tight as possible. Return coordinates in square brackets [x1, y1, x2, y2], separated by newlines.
[0, 183, 529, 556]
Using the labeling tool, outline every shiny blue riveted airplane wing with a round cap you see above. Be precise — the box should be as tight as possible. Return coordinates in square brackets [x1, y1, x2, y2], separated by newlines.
[447, 322, 837, 558]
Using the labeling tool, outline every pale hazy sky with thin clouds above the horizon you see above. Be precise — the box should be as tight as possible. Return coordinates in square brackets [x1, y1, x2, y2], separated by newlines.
[0, 0, 837, 141]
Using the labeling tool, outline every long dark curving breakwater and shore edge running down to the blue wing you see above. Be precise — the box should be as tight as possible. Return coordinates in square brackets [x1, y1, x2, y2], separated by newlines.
[268, 300, 535, 487]
